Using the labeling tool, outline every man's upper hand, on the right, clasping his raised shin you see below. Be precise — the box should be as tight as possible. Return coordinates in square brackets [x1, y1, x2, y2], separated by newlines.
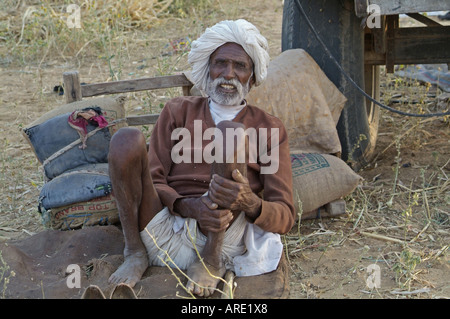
[208, 169, 262, 220]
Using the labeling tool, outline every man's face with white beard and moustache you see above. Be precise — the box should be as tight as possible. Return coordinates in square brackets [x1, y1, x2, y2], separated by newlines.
[206, 43, 255, 105]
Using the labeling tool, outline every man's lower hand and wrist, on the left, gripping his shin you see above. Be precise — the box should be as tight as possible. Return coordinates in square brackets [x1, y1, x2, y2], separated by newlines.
[174, 196, 233, 234]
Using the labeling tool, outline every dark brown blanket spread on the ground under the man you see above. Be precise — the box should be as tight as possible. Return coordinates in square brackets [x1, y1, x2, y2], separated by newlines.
[0, 226, 289, 299]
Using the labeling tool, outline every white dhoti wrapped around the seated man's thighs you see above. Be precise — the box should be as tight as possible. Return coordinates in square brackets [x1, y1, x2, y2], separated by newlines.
[140, 207, 283, 276]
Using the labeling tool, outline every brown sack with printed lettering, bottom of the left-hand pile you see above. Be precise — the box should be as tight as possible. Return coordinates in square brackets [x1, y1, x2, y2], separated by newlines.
[41, 194, 119, 230]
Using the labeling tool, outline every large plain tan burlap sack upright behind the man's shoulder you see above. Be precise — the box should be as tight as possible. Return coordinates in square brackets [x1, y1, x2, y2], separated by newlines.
[247, 49, 346, 154]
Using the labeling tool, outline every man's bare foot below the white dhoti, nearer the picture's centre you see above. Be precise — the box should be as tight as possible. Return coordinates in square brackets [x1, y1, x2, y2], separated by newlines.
[186, 260, 226, 297]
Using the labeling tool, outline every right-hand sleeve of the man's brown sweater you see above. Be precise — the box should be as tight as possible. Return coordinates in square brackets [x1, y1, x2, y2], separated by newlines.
[254, 123, 295, 234]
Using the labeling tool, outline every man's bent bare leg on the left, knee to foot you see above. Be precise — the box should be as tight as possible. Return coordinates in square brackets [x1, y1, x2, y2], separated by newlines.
[108, 127, 163, 287]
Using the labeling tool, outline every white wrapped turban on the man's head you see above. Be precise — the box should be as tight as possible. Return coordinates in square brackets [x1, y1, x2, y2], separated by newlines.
[188, 19, 270, 91]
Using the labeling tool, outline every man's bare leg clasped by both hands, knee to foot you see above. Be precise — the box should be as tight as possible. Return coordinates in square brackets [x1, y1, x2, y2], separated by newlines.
[187, 121, 248, 297]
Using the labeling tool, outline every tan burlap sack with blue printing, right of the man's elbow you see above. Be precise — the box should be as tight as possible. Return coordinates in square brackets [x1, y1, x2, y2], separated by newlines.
[291, 153, 362, 213]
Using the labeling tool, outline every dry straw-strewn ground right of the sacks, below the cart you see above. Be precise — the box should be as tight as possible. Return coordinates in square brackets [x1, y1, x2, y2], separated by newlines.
[285, 69, 450, 298]
